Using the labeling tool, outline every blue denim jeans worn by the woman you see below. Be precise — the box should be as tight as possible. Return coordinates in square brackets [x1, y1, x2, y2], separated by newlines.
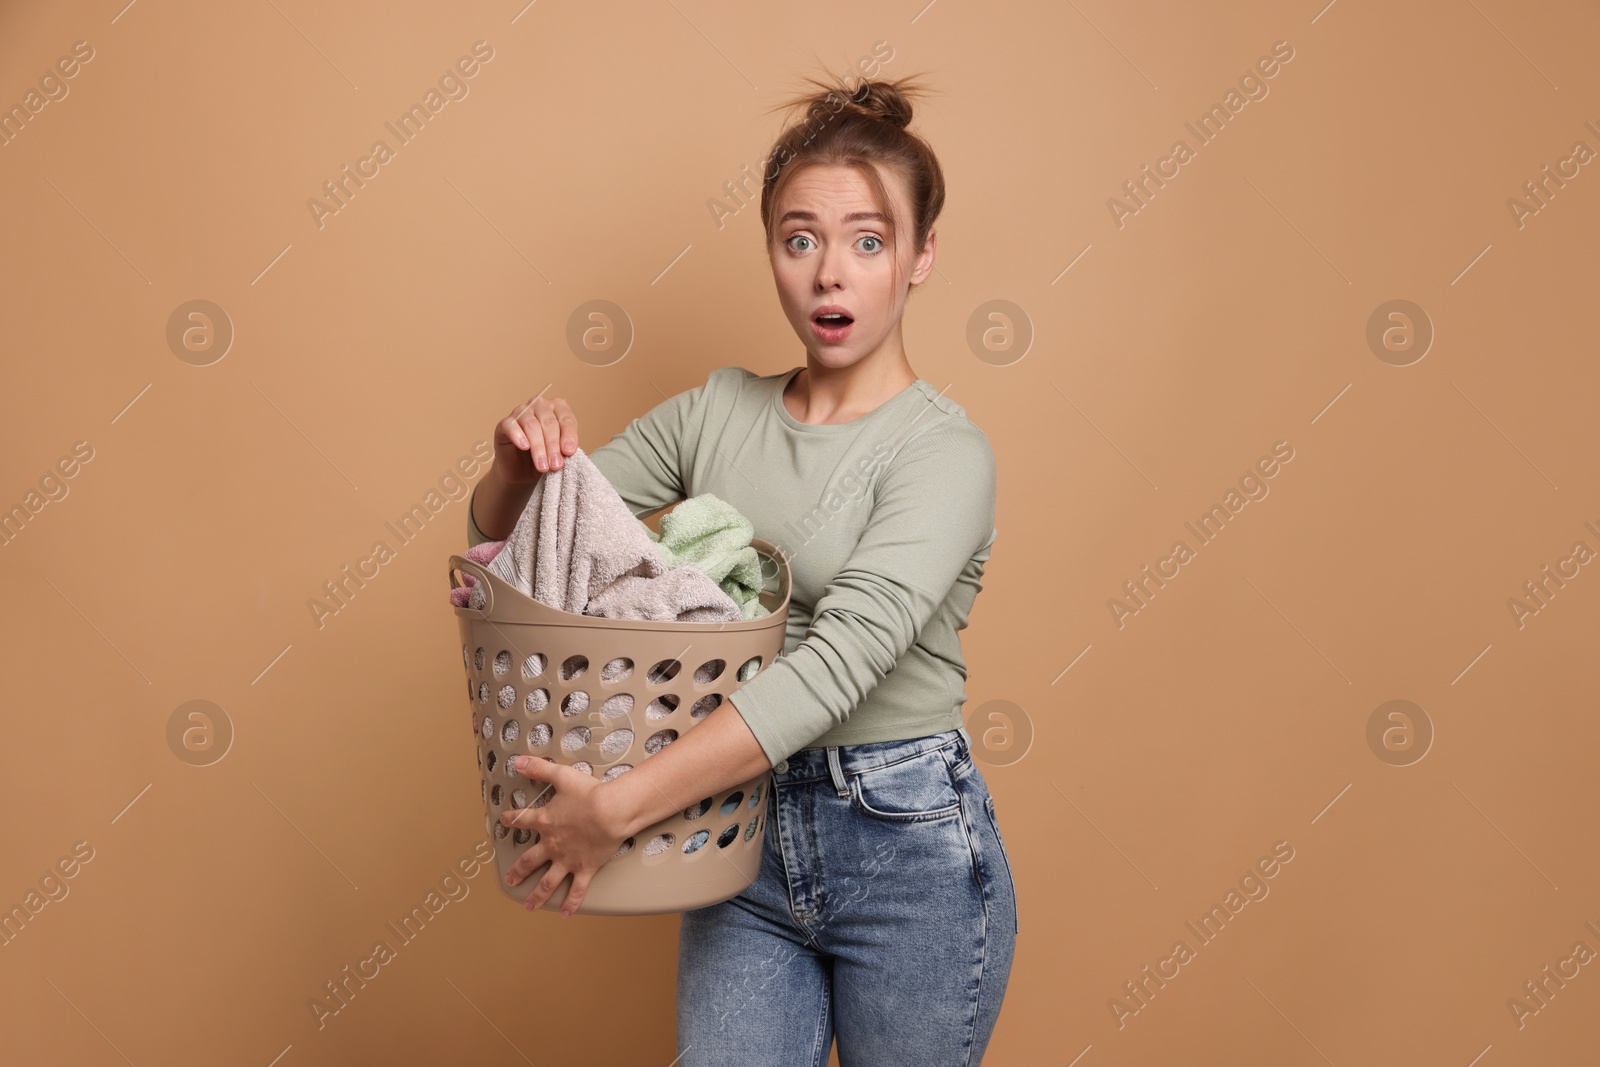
[677, 728, 1018, 1067]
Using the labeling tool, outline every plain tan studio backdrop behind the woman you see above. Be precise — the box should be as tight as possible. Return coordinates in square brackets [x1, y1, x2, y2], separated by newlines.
[0, 0, 1600, 1067]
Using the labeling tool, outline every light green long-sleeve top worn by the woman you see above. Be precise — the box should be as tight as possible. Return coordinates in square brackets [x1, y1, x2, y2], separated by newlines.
[467, 366, 997, 763]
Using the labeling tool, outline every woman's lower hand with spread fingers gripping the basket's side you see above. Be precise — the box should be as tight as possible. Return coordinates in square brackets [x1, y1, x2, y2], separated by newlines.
[501, 755, 627, 918]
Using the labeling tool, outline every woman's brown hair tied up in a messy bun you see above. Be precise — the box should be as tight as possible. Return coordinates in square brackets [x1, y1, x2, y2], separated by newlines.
[762, 75, 944, 292]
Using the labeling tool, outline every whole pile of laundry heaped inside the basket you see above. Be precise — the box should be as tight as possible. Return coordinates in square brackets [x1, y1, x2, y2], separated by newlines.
[450, 448, 770, 622]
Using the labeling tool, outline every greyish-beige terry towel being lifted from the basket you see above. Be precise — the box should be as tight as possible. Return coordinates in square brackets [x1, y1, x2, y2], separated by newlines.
[469, 448, 744, 622]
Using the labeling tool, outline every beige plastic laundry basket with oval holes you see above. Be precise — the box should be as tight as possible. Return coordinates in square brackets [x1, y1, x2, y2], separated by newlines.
[450, 537, 790, 915]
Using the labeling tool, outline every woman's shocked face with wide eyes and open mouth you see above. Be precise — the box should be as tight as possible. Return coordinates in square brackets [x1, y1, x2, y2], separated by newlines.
[768, 165, 934, 368]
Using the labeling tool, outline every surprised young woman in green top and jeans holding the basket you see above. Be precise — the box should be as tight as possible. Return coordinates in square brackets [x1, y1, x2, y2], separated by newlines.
[469, 78, 1018, 1067]
